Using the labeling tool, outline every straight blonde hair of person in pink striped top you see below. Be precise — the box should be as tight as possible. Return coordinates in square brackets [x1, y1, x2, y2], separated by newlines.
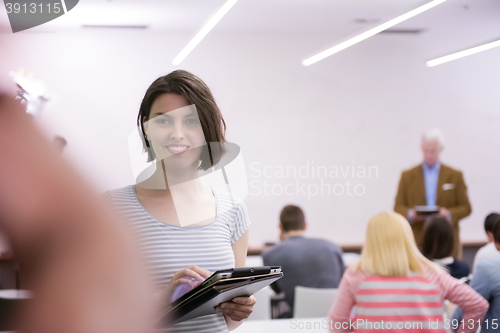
[354, 212, 437, 276]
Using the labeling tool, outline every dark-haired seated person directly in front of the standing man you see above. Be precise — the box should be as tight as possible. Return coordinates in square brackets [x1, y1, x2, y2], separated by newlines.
[422, 216, 469, 279]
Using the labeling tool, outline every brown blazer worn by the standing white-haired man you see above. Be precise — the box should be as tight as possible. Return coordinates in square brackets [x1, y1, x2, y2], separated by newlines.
[394, 163, 472, 258]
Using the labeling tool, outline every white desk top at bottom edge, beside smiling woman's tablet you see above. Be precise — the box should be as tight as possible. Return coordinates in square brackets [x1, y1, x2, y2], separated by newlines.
[232, 318, 330, 333]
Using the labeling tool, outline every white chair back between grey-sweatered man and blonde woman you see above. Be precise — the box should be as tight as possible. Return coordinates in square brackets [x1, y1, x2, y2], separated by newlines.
[293, 286, 337, 318]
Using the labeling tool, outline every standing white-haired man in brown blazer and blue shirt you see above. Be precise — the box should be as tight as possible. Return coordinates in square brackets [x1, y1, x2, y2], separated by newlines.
[394, 129, 472, 259]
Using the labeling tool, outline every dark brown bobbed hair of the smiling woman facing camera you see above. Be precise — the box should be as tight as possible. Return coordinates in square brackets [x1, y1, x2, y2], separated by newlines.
[137, 70, 226, 170]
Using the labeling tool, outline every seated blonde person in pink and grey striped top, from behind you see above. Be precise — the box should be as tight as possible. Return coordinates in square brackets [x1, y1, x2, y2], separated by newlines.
[329, 212, 488, 333]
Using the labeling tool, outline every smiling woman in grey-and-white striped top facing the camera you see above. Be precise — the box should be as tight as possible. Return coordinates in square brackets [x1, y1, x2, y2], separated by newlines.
[105, 70, 255, 332]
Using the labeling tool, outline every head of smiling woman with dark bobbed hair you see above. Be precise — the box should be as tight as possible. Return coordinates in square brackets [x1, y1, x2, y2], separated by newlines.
[137, 70, 226, 170]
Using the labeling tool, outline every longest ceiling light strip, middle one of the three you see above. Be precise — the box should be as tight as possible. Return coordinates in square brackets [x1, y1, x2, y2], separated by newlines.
[302, 0, 446, 66]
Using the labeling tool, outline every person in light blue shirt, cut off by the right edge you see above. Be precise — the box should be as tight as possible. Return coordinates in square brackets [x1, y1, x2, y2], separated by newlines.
[451, 218, 500, 333]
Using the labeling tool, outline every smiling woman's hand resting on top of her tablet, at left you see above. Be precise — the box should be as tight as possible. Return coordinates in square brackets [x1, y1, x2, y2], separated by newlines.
[160, 266, 212, 304]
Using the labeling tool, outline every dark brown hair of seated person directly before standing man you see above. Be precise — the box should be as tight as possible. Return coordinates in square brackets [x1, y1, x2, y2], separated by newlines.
[422, 217, 454, 260]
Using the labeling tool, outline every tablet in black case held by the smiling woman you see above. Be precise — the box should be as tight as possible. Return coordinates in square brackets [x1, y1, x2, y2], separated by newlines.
[160, 266, 283, 325]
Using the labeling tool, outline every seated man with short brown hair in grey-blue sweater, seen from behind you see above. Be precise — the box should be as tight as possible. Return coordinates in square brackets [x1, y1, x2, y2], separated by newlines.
[262, 205, 345, 318]
